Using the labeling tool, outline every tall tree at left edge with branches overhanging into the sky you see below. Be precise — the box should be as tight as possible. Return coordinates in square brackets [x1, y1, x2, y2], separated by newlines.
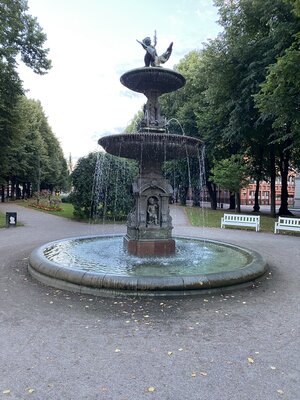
[0, 0, 51, 192]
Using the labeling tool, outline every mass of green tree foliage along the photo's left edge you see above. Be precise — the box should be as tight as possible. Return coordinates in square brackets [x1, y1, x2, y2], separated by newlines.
[0, 0, 68, 197]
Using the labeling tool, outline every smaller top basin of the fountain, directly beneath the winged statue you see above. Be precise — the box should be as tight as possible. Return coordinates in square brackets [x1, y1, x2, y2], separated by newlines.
[120, 67, 185, 94]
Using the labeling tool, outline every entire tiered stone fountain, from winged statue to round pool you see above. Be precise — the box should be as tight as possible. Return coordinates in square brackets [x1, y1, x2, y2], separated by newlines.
[29, 38, 266, 296]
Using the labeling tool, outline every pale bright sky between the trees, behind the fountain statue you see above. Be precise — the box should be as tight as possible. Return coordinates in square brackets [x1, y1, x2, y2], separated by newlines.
[19, 0, 221, 162]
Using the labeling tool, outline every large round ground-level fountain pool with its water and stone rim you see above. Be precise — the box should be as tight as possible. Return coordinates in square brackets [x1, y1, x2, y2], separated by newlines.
[28, 236, 267, 296]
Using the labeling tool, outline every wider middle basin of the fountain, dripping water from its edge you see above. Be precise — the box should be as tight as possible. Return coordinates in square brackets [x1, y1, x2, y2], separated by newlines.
[98, 132, 202, 162]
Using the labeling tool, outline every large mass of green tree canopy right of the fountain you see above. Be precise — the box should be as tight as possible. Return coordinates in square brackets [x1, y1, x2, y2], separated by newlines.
[162, 0, 300, 214]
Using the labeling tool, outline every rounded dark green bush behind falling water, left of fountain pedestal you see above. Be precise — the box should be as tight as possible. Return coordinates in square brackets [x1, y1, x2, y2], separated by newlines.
[70, 153, 137, 221]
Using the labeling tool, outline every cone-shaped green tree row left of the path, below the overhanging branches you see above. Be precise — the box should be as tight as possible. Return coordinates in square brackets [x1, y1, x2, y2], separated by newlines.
[6, 96, 68, 197]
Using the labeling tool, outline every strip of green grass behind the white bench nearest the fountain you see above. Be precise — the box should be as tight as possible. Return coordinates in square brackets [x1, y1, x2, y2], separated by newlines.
[186, 207, 276, 233]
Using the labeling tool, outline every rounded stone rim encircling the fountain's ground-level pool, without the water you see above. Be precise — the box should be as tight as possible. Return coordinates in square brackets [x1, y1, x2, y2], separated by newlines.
[28, 234, 268, 297]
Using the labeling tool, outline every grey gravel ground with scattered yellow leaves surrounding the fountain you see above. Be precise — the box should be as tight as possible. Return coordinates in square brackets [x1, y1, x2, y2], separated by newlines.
[0, 204, 300, 400]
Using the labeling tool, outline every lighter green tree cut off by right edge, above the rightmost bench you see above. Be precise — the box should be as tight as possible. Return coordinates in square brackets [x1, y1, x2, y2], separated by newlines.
[254, 0, 300, 215]
